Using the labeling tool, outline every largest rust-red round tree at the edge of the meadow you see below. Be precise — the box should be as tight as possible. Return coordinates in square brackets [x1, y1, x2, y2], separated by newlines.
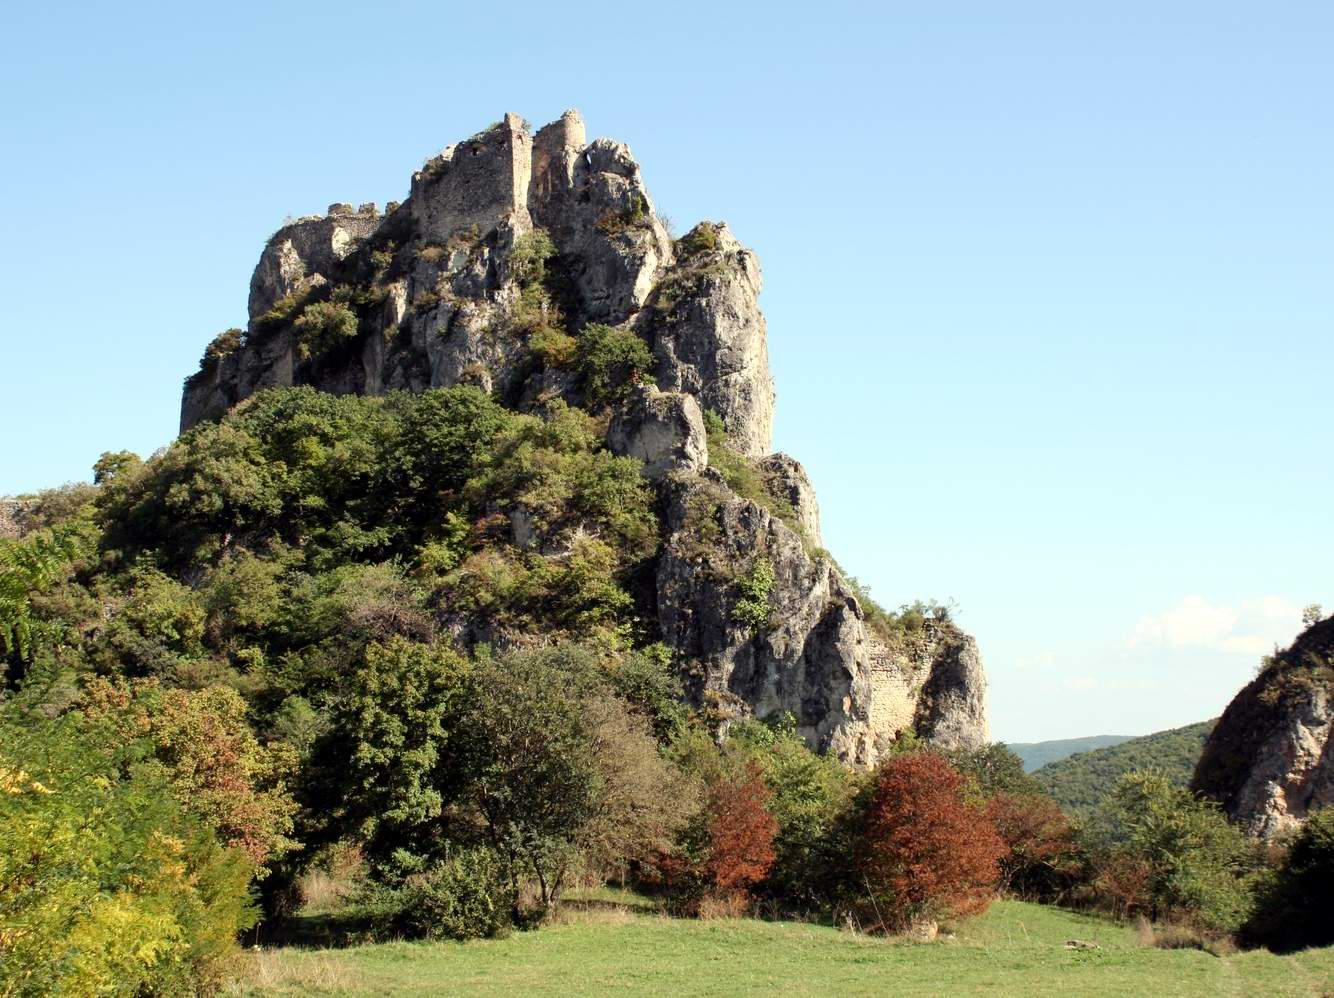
[855, 753, 1006, 931]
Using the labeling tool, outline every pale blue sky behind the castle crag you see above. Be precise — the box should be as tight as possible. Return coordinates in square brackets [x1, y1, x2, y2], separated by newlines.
[0, 0, 1334, 740]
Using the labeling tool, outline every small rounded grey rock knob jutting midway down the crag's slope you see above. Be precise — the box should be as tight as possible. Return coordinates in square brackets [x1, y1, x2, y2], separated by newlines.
[607, 386, 708, 479]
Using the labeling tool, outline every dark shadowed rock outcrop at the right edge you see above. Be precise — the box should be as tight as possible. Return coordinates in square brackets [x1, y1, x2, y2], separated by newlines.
[1191, 618, 1334, 838]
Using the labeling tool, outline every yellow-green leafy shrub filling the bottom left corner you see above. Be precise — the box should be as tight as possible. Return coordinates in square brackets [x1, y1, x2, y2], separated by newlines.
[0, 675, 253, 994]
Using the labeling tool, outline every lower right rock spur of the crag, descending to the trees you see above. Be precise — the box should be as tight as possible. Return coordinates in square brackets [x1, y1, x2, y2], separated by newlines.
[656, 471, 987, 766]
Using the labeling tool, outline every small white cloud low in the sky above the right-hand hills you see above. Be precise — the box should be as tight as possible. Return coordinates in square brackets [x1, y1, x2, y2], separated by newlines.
[1127, 595, 1302, 658]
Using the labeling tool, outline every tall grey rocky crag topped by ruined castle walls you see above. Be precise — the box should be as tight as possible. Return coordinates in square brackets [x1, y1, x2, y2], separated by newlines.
[172, 111, 987, 765]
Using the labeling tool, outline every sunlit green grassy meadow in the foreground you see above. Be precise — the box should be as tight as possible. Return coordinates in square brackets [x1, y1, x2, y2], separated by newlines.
[231, 898, 1334, 998]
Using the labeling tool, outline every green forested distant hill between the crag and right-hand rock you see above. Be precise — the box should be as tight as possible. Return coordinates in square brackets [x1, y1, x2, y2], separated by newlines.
[1029, 718, 1218, 814]
